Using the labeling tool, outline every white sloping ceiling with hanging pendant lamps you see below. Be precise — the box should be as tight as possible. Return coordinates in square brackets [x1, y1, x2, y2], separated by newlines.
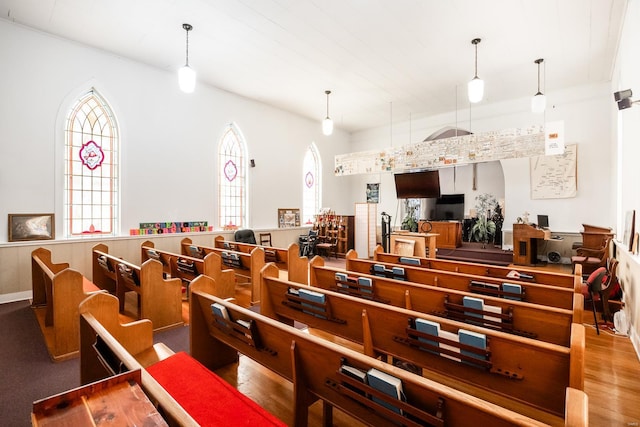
[0, 0, 627, 131]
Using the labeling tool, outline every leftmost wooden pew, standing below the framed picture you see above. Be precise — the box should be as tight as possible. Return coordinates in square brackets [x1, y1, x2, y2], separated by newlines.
[31, 248, 101, 362]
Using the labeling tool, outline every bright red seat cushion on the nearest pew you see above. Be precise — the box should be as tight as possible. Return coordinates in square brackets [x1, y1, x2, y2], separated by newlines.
[147, 352, 286, 427]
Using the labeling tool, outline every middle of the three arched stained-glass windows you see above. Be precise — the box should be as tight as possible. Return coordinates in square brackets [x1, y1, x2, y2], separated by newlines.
[218, 123, 248, 228]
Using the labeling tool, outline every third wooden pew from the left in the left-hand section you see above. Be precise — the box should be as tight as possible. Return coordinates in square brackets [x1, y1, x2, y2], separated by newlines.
[140, 241, 236, 298]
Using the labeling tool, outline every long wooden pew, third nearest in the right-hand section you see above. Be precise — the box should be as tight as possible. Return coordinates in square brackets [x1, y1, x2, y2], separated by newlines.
[310, 260, 584, 346]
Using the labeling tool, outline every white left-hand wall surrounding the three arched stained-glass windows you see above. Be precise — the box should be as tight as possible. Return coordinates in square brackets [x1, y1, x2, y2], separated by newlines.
[0, 19, 351, 242]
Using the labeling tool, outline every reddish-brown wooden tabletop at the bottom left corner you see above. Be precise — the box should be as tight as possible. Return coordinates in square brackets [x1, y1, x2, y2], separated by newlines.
[31, 370, 167, 427]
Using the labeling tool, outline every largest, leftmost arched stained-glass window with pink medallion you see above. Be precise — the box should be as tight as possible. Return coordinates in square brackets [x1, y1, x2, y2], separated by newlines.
[64, 88, 119, 237]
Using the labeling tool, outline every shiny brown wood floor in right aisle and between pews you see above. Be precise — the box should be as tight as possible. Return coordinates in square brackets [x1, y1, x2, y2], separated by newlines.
[141, 262, 640, 427]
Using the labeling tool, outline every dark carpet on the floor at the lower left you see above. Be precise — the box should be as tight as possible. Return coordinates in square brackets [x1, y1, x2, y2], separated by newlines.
[0, 301, 189, 427]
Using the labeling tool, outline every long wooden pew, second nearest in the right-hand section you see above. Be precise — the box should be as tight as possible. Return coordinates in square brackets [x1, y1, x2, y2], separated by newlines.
[260, 267, 585, 422]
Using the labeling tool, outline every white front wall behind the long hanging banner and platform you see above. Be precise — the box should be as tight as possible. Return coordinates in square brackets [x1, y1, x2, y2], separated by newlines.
[351, 81, 616, 232]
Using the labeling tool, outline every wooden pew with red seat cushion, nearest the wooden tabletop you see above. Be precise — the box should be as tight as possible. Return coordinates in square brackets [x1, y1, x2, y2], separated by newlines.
[80, 294, 284, 426]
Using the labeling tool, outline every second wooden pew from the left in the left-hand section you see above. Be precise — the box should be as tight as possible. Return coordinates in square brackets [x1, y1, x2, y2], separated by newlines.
[92, 244, 183, 330]
